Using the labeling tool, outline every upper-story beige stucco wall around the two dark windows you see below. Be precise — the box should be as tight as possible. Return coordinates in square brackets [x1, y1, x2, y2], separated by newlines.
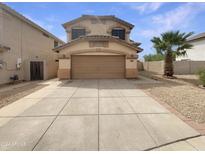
[66, 19, 130, 42]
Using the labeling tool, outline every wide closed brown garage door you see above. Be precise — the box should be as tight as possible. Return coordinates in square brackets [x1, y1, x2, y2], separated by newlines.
[71, 55, 125, 79]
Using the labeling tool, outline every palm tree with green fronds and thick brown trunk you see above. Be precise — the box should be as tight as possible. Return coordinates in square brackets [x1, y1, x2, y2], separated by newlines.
[151, 31, 193, 77]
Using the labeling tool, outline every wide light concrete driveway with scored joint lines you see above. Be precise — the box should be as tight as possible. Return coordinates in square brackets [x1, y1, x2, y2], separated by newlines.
[0, 80, 203, 150]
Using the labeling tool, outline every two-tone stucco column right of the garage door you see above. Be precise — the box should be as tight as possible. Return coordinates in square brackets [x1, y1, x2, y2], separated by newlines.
[125, 57, 138, 78]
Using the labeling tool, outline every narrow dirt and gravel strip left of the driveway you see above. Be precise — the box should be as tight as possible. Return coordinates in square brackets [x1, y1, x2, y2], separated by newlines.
[0, 82, 47, 108]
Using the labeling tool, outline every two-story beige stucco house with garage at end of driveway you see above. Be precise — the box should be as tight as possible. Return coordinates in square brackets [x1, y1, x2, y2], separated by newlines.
[54, 15, 142, 79]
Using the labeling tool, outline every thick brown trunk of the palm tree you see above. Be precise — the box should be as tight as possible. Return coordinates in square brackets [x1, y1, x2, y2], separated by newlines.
[164, 51, 174, 77]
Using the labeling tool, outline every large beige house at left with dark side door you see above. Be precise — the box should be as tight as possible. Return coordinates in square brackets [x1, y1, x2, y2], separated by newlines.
[0, 3, 64, 84]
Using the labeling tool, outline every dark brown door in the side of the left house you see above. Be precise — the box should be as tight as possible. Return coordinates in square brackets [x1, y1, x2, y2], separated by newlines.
[30, 61, 43, 80]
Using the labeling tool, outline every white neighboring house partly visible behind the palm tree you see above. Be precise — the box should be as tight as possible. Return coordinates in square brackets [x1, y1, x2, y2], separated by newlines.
[176, 33, 205, 61]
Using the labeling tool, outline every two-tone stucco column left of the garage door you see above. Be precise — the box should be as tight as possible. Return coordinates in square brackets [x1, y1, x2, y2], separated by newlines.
[58, 59, 71, 79]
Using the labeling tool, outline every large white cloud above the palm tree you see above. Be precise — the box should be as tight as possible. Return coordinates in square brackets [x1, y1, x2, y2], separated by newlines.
[140, 3, 205, 37]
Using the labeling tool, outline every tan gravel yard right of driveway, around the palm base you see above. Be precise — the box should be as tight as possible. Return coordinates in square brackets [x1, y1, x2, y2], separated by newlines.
[138, 72, 205, 123]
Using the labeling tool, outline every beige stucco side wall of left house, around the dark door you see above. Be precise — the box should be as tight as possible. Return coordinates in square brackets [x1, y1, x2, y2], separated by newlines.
[0, 7, 58, 84]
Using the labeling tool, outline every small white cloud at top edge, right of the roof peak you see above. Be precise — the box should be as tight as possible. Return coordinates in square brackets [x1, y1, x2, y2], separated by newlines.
[130, 2, 164, 14]
